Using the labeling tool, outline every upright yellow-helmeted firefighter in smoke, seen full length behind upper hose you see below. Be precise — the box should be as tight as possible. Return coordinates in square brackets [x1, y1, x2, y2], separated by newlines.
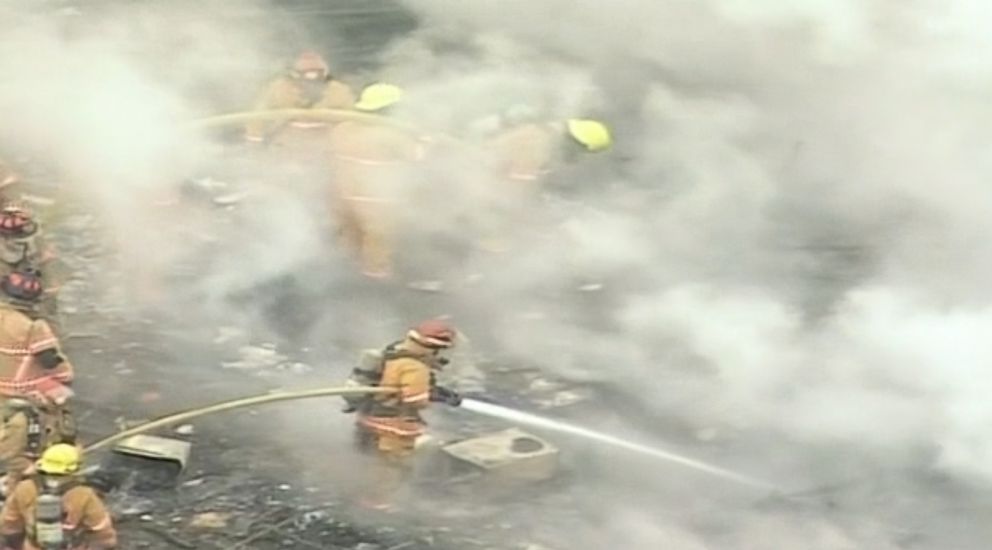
[330, 83, 427, 279]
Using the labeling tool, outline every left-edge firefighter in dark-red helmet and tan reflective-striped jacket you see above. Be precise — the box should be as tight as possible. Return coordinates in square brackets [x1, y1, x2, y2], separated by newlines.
[0, 270, 73, 406]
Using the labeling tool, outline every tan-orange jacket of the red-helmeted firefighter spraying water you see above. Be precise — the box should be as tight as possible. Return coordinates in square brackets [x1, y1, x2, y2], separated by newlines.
[358, 338, 434, 438]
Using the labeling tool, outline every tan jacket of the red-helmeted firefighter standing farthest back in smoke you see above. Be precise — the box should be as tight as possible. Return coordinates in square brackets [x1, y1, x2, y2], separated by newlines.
[245, 76, 355, 141]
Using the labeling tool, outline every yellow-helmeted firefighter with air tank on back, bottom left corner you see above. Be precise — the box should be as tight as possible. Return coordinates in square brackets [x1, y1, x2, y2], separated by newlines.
[0, 444, 117, 550]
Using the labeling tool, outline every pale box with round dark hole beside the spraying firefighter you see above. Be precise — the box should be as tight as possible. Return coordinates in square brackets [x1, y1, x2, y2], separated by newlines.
[441, 428, 559, 481]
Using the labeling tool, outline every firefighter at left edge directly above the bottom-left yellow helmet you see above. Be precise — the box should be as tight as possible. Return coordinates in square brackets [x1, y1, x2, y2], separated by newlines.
[0, 397, 76, 495]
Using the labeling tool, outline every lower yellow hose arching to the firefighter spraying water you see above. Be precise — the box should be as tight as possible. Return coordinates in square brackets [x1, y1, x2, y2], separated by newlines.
[85, 386, 396, 452]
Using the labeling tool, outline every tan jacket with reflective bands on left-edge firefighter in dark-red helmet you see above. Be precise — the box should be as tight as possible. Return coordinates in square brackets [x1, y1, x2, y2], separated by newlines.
[0, 304, 73, 401]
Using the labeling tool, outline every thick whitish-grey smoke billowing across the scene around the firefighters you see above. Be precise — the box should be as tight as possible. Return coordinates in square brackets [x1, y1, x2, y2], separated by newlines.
[0, 0, 992, 549]
